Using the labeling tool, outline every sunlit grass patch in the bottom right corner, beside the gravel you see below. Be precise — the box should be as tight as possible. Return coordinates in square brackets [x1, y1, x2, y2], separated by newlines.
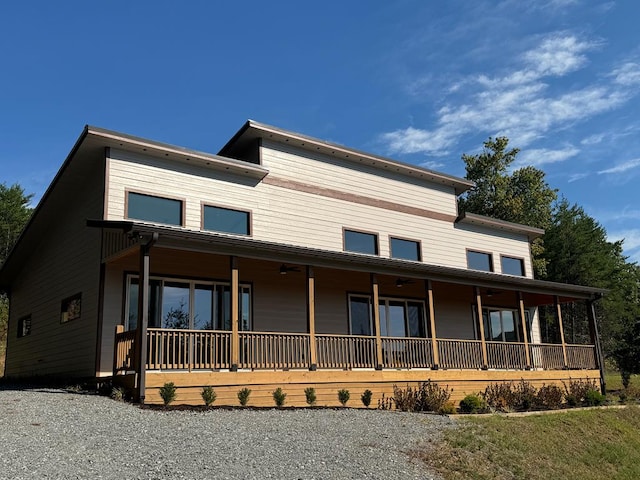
[418, 406, 640, 480]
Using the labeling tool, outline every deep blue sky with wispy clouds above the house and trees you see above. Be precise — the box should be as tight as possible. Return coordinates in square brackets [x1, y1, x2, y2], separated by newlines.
[0, 0, 640, 260]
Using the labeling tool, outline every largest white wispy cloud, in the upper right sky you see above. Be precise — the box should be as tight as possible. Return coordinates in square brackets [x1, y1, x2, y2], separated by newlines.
[381, 32, 638, 158]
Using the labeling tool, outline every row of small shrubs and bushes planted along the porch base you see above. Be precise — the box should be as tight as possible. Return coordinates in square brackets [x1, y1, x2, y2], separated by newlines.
[120, 380, 606, 414]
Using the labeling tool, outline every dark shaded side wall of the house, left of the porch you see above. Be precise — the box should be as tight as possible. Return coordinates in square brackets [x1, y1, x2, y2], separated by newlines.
[5, 158, 104, 377]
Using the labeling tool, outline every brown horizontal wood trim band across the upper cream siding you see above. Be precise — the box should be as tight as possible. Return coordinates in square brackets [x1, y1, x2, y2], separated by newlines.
[262, 175, 457, 223]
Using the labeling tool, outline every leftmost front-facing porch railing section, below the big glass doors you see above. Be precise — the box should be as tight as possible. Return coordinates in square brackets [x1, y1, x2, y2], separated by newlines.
[147, 328, 231, 370]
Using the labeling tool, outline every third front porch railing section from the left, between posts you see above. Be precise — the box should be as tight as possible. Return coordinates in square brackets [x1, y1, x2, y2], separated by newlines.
[316, 334, 376, 369]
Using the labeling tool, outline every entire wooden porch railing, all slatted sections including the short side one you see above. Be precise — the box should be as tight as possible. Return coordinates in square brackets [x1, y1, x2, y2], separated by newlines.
[114, 328, 597, 374]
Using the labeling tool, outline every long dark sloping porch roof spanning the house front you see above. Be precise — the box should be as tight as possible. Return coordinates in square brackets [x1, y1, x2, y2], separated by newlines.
[87, 220, 607, 304]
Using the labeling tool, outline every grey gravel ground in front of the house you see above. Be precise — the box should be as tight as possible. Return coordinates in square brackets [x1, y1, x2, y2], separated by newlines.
[0, 389, 454, 480]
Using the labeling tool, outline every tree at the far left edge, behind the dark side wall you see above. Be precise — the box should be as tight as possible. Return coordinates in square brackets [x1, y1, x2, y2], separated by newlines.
[0, 183, 33, 264]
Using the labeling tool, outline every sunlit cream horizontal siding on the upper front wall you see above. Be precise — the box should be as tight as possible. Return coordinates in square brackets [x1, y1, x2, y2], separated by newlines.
[106, 148, 531, 276]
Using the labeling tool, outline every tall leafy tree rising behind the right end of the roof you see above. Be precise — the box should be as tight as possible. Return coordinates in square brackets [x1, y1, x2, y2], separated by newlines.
[458, 137, 557, 277]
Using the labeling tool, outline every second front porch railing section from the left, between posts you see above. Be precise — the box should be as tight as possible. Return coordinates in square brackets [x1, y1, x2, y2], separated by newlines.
[238, 332, 310, 370]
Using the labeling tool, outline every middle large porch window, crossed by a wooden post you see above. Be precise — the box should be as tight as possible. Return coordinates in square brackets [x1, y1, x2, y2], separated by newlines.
[349, 295, 428, 338]
